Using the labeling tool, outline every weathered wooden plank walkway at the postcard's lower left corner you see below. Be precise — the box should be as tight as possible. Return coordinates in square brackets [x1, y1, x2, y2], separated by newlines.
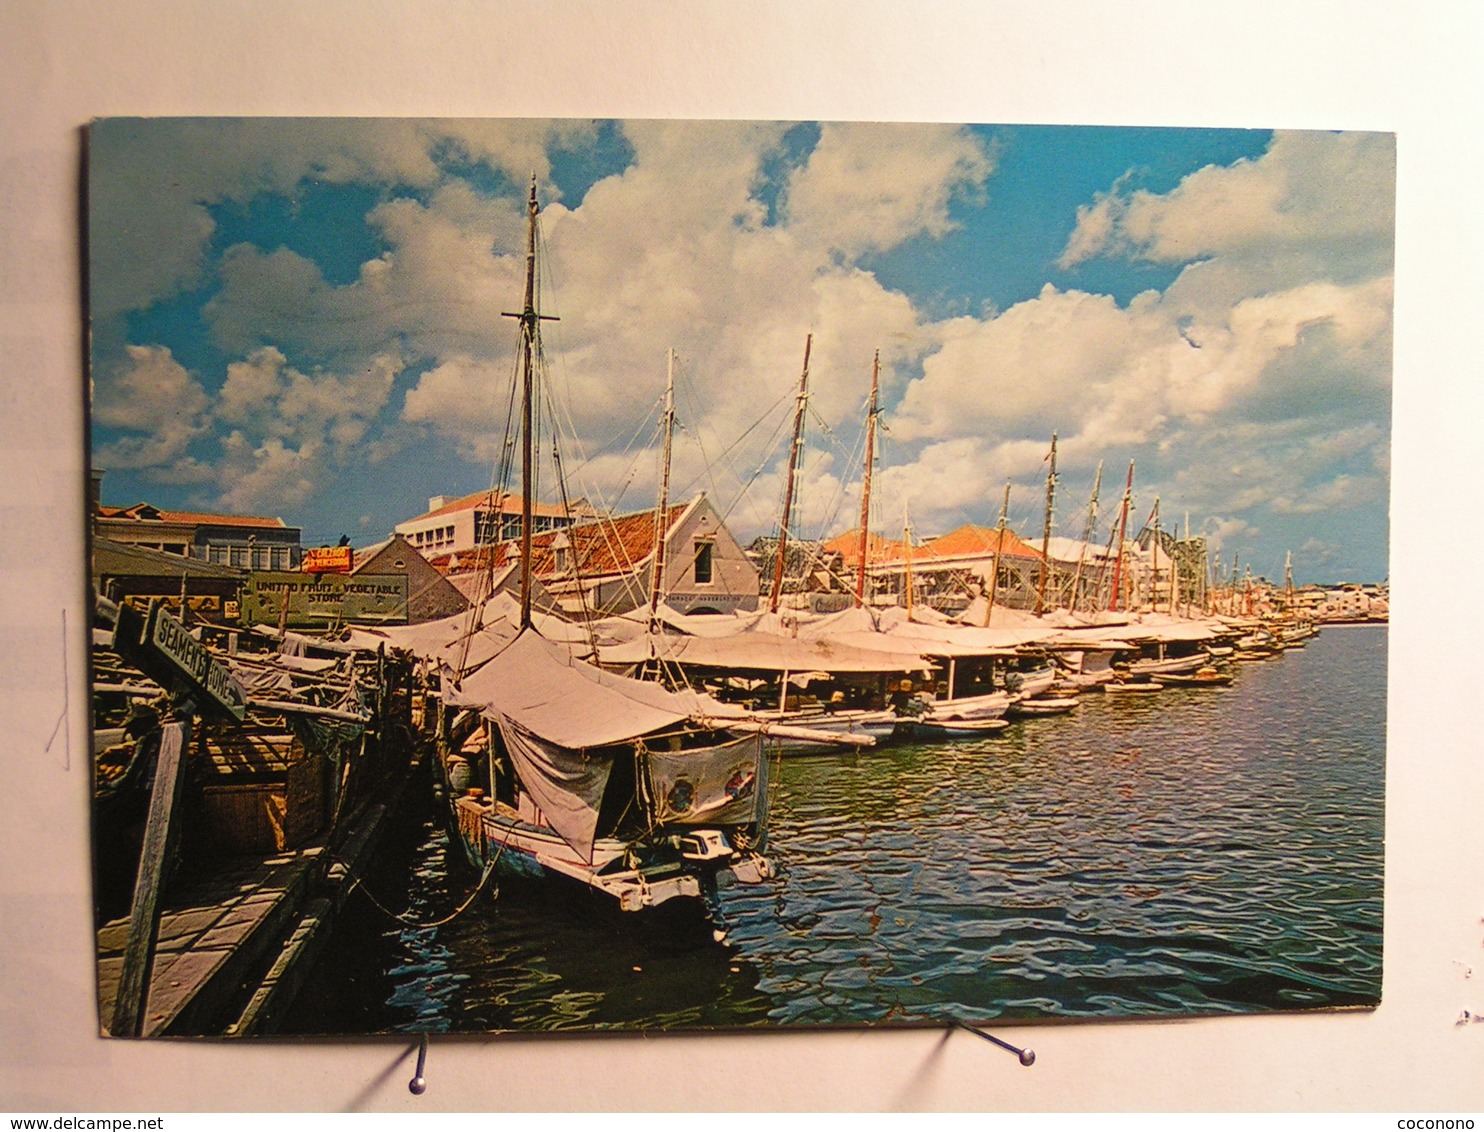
[98, 846, 324, 1037]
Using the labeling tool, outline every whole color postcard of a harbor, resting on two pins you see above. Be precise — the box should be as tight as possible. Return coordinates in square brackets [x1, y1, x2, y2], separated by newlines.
[88, 119, 1396, 1037]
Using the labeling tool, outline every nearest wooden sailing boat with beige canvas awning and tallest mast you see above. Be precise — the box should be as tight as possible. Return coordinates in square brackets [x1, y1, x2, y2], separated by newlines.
[438, 178, 770, 911]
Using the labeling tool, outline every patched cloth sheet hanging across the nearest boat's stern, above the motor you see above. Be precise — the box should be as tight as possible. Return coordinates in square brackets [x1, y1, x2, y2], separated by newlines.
[647, 734, 767, 825]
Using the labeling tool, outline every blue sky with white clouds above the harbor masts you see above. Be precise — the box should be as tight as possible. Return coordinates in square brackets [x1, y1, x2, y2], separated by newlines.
[89, 119, 1395, 582]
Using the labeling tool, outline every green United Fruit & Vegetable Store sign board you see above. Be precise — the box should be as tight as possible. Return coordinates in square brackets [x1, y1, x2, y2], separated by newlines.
[242, 571, 407, 629]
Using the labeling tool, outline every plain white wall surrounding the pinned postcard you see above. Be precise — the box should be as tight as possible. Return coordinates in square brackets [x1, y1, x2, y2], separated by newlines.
[0, 0, 1484, 1113]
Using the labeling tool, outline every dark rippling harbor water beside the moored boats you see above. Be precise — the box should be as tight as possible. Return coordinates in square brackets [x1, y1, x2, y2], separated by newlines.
[286, 626, 1386, 1034]
